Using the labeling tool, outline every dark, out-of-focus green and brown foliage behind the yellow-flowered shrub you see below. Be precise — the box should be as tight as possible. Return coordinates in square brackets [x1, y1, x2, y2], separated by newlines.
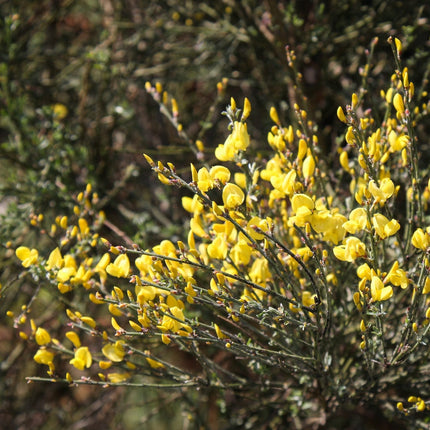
[0, 0, 430, 429]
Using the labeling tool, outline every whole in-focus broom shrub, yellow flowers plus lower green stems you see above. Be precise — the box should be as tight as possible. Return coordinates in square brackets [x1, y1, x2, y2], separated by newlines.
[9, 38, 430, 428]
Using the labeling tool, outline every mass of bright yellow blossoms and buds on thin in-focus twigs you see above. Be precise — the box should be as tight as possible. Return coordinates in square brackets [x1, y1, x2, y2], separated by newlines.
[10, 40, 430, 420]
